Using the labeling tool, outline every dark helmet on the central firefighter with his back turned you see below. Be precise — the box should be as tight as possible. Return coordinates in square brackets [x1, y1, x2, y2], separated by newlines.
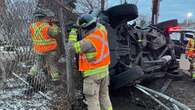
[77, 14, 97, 30]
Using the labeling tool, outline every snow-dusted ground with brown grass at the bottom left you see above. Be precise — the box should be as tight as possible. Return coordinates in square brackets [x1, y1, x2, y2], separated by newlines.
[0, 78, 71, 110]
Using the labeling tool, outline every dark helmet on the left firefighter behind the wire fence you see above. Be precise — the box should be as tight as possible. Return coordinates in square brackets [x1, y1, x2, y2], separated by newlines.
[33, 9, 55, 18]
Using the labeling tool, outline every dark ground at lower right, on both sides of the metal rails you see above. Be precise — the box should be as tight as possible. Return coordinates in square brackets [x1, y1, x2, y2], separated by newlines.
[112, 71, 195, 110]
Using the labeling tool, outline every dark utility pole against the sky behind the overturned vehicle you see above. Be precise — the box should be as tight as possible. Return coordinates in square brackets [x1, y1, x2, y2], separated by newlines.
[152, 0, 160, 24]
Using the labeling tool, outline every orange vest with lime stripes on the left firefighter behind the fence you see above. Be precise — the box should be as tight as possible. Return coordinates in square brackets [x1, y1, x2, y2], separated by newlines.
[30, 22, 57, 54]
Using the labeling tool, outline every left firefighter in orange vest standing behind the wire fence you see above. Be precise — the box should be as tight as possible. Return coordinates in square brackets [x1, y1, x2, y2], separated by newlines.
[27, 9, 60, 91]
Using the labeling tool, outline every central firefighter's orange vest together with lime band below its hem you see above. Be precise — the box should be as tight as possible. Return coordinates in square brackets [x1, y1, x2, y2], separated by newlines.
[79, 23, 110, 76]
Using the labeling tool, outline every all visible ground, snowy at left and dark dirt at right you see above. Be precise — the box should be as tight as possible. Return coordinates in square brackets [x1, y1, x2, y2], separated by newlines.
[0, 70, 195, 110]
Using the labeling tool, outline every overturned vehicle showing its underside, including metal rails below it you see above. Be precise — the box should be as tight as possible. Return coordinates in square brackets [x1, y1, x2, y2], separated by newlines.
[95, 4, 190, 110]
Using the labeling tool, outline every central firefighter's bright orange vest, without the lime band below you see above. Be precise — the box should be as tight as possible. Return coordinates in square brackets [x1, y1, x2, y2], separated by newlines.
[79, 28, 110, 71]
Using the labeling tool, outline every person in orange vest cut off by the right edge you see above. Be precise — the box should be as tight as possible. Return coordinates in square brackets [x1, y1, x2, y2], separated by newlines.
[186, 36, 195, 81]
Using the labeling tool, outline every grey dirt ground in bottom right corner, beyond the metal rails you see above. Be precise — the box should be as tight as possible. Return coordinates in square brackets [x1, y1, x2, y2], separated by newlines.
[145, 71, 195, 110]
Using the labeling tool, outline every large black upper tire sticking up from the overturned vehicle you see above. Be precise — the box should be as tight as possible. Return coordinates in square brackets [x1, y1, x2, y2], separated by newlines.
[104, 4, 138, 27]
